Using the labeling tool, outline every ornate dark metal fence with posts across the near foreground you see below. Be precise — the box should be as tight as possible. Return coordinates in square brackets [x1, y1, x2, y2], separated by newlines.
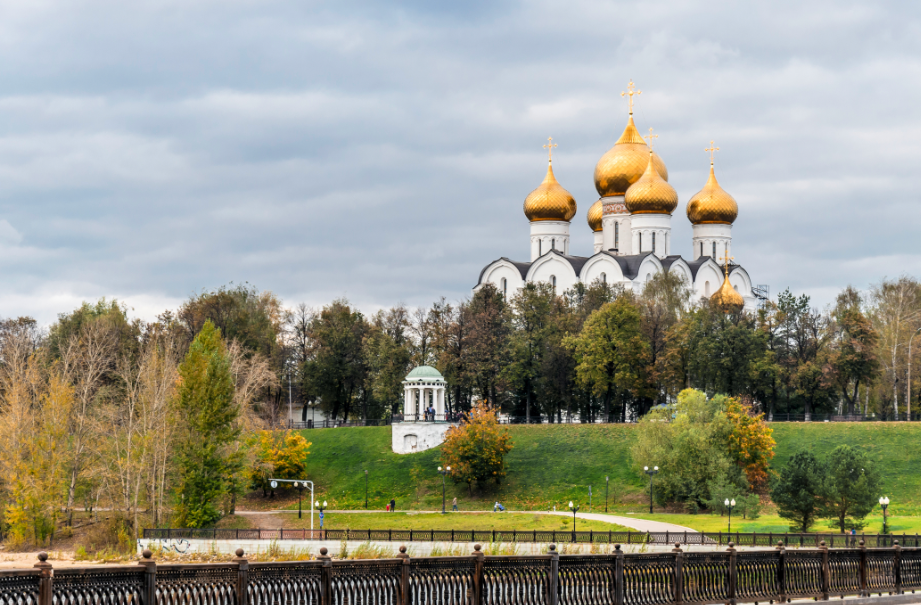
[16, 543, 921, 605]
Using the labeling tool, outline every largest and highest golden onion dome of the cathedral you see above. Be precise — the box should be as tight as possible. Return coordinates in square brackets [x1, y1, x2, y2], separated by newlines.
[595, 115, 668, 197]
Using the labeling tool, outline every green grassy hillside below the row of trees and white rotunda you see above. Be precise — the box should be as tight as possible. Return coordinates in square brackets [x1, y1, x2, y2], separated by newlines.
[290, 423, 921, 515]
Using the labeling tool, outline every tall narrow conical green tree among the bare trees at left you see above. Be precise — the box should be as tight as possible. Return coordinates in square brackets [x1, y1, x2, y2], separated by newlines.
[175, 321, 241, 527]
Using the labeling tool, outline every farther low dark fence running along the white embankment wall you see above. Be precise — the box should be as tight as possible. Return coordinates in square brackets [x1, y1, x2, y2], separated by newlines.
[144, 529, 921, 548]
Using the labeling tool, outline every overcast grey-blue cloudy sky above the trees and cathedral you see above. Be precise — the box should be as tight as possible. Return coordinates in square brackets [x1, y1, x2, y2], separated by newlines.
[0, 0, 921, 323]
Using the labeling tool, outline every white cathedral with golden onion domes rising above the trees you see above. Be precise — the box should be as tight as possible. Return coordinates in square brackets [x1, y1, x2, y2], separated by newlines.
[477, 82, 760, 311]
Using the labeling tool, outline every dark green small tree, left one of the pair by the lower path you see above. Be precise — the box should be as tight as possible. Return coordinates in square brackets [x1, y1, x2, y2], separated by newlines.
[771, 451, 825, 533]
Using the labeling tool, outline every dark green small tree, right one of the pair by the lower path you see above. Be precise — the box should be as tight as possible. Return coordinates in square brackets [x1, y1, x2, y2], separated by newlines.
[819, 445, 880, 533]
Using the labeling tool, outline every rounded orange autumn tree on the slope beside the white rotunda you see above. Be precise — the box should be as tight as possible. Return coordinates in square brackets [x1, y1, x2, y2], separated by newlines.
[441, 402, 512, 496]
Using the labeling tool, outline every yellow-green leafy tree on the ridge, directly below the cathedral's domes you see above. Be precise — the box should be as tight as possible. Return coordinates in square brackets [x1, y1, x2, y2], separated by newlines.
[567, 296, 649, 420]
